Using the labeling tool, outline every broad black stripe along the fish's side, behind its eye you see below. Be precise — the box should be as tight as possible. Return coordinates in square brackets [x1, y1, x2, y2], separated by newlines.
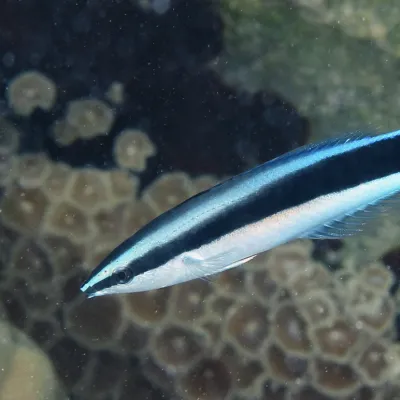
[94, 132, 400, 282]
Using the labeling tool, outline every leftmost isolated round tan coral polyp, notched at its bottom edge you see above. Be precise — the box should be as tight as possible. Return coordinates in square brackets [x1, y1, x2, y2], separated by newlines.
[7, 71, 56, 117]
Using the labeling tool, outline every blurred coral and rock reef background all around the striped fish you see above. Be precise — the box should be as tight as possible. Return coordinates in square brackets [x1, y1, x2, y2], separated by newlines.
[0, 0, 400, 400]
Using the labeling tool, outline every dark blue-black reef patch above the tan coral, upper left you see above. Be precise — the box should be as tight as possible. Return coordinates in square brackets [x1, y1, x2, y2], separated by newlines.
[0, 0, 309, 177]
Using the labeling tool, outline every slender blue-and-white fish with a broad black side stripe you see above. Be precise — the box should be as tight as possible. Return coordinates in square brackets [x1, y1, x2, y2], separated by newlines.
[81, 131, 400, 297]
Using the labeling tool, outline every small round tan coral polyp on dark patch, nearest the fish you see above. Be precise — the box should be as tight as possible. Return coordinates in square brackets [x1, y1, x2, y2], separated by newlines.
[114, 129, 156, 172]
